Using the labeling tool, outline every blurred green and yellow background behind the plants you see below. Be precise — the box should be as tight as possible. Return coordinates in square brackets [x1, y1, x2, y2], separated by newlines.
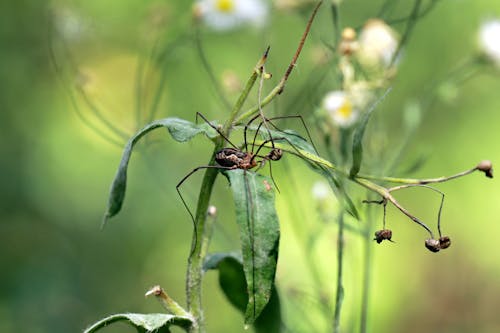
[0, 0, 500, 333]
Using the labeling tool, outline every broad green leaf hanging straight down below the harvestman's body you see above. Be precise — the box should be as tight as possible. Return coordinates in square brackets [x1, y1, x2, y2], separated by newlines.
[224, 170, 280, 324]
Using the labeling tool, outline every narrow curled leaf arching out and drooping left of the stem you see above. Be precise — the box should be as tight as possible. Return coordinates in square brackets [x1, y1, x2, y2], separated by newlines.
[102, 118, 217, 226]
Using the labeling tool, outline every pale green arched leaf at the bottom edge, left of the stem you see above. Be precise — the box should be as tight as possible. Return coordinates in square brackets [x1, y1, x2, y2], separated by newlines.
[84, 313, 193, 333]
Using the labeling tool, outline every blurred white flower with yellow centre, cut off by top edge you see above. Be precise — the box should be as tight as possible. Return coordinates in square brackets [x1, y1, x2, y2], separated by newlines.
[195, 0, 269, 31]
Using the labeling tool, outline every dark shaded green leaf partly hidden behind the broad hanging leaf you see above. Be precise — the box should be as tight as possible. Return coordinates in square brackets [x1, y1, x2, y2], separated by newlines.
[203, 253, 281, 333]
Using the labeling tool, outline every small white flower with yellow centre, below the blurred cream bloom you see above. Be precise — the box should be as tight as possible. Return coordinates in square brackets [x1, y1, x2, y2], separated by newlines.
[323, 90, 359, 128]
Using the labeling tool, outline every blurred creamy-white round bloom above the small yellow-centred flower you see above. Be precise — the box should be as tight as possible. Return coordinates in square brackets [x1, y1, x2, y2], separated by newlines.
[359, 19, 399, 67]
